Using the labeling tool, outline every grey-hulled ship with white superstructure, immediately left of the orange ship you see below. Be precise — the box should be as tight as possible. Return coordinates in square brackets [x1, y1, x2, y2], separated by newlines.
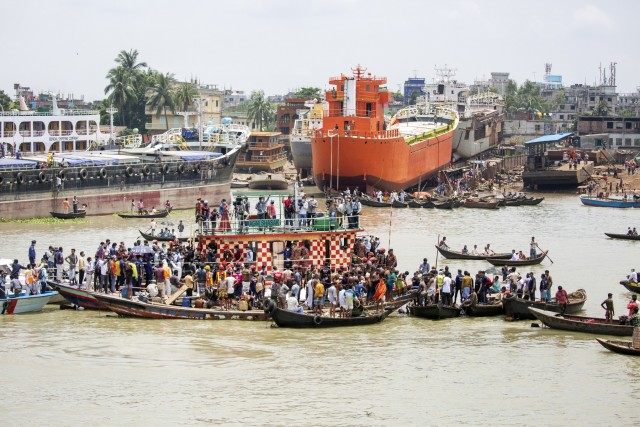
[291, 101, 324, 177]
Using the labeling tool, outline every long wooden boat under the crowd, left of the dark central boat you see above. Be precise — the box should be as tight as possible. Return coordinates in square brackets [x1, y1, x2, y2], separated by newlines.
[93, 293, 267, 320]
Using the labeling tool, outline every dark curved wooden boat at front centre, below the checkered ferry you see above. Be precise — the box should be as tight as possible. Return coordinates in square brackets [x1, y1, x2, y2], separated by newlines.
[264, 300, 393, 328]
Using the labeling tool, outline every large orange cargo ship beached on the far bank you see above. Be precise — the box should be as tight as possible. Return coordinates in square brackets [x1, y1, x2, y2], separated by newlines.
[311, 66, 458, 191]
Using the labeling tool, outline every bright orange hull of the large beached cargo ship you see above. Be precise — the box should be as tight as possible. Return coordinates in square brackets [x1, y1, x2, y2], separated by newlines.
[311, 130, 453, 191]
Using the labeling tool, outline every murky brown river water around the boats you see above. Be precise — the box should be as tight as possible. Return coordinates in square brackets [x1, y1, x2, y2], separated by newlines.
[0, 195, 640, 426]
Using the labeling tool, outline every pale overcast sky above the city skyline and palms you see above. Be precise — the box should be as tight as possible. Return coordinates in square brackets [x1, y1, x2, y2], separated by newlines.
[0, 0, 640, 100]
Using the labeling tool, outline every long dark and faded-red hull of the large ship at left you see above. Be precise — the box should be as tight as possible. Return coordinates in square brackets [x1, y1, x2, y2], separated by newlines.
[0, 150, 238, 220]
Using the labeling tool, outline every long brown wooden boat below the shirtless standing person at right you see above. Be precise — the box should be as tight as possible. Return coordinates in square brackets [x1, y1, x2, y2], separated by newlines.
[529, 307, 633, 337]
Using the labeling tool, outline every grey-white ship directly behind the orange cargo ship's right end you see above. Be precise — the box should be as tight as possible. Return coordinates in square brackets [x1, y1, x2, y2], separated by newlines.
[418, 68, 506, 160]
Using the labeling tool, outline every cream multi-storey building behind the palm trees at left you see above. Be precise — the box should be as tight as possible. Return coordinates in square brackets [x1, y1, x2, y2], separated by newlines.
[145, 83, 223, 135]
